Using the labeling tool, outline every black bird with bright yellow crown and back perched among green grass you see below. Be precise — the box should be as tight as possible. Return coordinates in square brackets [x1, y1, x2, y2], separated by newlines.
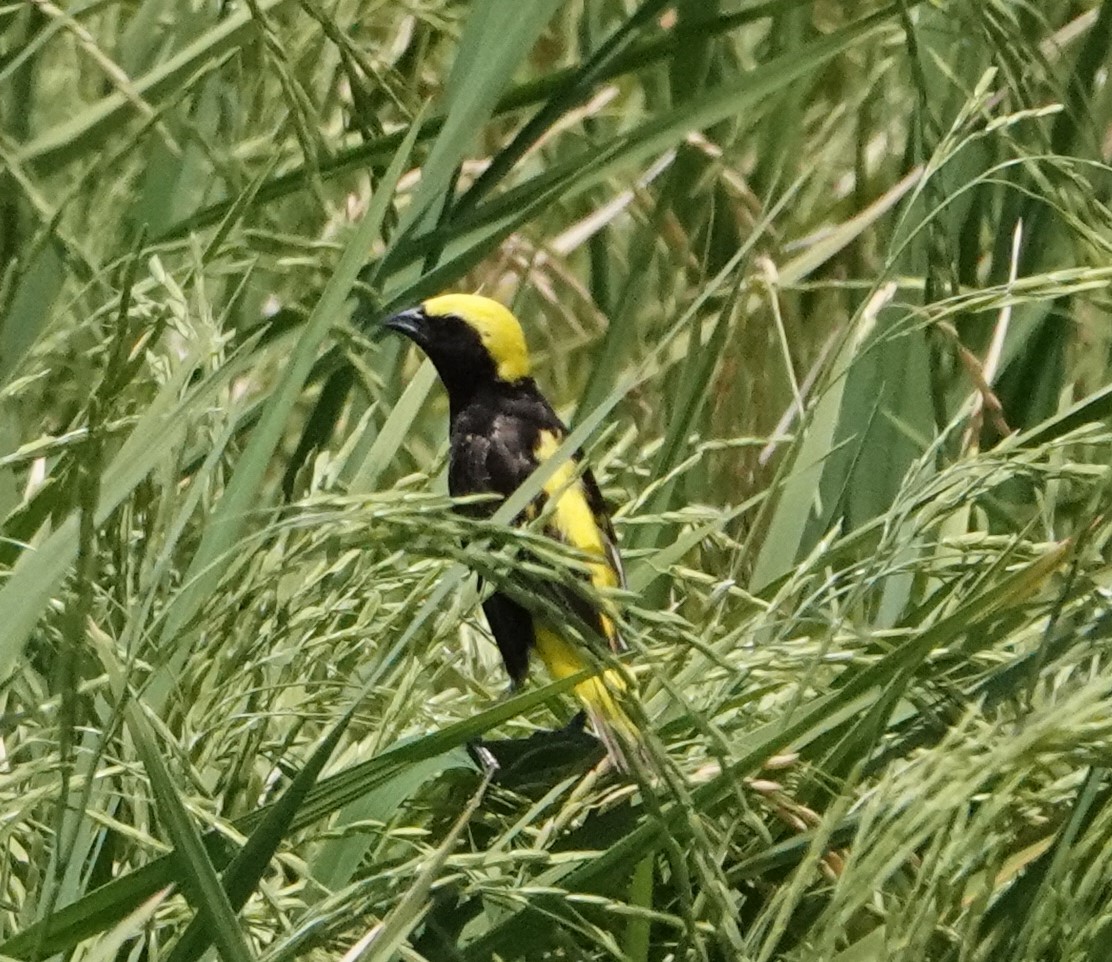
[385, 294, 638, 771]
